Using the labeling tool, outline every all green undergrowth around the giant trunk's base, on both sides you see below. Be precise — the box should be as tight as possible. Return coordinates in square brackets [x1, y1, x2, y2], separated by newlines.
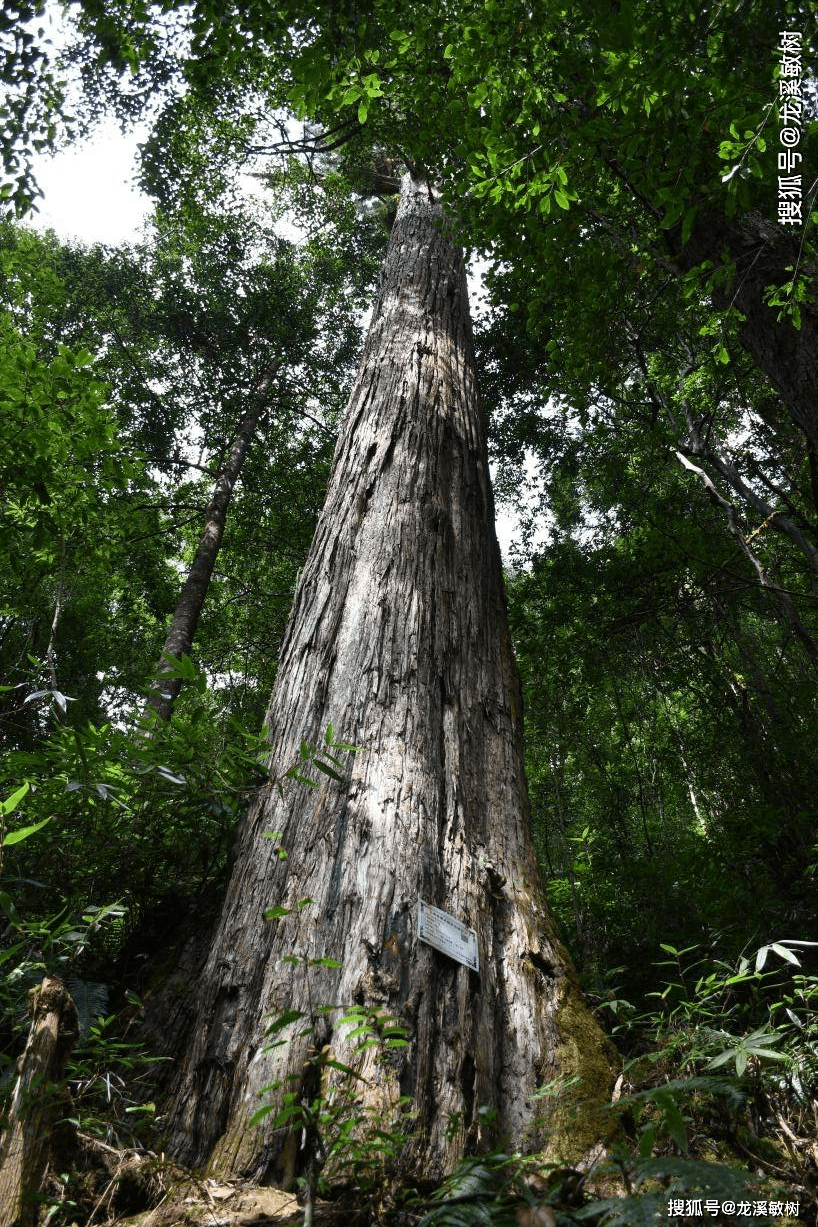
[0, 661, 818, 1227]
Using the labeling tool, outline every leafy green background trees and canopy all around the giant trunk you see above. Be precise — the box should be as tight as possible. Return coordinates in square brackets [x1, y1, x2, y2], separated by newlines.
[0, 0, 818, 1222]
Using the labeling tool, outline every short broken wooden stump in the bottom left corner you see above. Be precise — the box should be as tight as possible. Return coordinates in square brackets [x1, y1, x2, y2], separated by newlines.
[0, 977, 80, 1227]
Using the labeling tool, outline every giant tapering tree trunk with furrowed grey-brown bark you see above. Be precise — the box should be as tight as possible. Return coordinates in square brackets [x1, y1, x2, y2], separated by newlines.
[159, 177, 612, 1180]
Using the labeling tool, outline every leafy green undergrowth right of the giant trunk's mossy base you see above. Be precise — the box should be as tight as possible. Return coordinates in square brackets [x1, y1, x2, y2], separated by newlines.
[407, 940, 818, 1227]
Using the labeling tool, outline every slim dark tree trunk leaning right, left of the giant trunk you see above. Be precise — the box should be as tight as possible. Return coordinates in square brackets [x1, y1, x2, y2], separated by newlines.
[148, 360, 281, 720]
